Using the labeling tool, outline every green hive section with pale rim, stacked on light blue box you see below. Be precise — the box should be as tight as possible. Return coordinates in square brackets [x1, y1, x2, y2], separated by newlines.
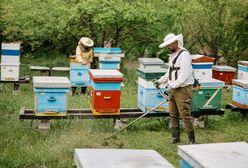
[136, 68, 167, 80]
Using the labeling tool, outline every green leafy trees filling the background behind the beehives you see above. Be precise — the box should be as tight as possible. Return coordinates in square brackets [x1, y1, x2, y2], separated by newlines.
[0, 0, 248, 63]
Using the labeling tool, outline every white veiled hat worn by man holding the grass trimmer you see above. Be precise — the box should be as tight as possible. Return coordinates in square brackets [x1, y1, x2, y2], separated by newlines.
[159, 33, 183, 48]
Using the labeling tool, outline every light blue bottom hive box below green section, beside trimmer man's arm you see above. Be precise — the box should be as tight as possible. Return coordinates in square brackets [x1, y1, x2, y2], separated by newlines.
[138, 77, 168, 112]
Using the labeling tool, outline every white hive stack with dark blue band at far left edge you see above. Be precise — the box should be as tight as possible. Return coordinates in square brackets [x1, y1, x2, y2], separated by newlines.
[1, 43, 20, 81]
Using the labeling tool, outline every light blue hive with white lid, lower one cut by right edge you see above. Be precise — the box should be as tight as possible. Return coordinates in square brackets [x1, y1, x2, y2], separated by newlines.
[232, 79, 248, 108]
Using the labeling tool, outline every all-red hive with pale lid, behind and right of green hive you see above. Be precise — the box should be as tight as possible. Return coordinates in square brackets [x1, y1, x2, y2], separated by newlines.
[213, 65, 236, 85]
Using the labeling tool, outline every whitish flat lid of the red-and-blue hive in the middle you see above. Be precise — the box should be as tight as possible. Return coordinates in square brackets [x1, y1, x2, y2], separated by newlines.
[90, 69, 123, 79]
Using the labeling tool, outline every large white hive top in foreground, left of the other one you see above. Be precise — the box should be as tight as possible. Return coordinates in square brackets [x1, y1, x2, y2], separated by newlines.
[74, 149, 174, 168]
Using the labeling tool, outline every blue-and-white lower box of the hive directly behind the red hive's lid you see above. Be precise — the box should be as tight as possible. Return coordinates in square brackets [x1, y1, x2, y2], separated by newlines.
[99, 57, 121, 69]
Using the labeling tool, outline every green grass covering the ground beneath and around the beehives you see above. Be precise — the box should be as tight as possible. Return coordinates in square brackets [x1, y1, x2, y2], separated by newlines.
[0, 52, 248, 168]
